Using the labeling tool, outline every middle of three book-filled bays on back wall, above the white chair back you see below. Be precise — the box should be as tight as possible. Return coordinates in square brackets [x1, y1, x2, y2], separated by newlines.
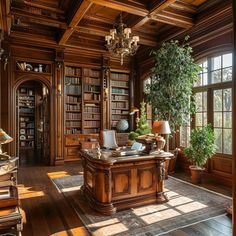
[83, 68, 101, 134]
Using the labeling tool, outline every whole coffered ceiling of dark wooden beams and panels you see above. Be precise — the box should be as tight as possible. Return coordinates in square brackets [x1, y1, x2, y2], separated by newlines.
[0, 0, 230, 51]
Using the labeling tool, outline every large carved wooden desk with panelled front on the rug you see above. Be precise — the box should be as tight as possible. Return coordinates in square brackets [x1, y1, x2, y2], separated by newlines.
[81, 150, 173, 215]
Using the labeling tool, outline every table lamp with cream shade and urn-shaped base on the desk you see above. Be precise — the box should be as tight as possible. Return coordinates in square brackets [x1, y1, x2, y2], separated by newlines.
[152, 120, 171, 152]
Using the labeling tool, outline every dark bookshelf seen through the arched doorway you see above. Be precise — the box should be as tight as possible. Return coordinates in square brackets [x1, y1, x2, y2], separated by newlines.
[18, 87, 35, 151]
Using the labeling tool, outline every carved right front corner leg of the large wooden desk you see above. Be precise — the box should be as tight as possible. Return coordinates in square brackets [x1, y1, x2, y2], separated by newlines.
[157, 159, 168, 203]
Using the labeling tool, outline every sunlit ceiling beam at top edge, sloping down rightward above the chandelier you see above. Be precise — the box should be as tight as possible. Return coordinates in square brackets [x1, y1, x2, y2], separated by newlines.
[90, 0, 149, 17]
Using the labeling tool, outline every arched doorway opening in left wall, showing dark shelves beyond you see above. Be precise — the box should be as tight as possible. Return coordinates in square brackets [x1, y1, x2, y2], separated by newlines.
[15, 80, 50, 166]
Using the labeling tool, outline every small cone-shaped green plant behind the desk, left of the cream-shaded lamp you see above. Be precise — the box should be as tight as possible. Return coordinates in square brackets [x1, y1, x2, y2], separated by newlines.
[129, 101, 151, 140]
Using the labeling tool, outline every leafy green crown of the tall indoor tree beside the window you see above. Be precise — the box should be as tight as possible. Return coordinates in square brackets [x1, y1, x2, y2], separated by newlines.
[145, 38, 201, 131]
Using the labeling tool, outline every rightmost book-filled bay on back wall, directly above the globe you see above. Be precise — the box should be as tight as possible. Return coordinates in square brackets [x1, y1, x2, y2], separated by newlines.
[110, 72, 130, 129]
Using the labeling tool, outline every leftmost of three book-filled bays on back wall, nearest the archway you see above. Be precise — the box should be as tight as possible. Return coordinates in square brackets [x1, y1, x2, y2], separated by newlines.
[64, 66, 82, 134]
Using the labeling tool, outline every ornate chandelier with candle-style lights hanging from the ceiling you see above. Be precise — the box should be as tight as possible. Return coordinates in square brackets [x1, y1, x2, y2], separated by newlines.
[105, 14, 139, 65]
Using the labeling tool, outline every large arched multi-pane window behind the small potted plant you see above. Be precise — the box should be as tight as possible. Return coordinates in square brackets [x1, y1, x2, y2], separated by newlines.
[180, 53, 232, 155]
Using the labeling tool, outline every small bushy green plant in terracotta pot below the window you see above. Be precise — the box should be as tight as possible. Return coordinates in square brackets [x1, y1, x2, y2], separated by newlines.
[184, 124, 216, 183]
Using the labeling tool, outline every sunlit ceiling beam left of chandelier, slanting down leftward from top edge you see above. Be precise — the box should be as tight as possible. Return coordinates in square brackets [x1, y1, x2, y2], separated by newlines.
[58, 0, 92, 45]
